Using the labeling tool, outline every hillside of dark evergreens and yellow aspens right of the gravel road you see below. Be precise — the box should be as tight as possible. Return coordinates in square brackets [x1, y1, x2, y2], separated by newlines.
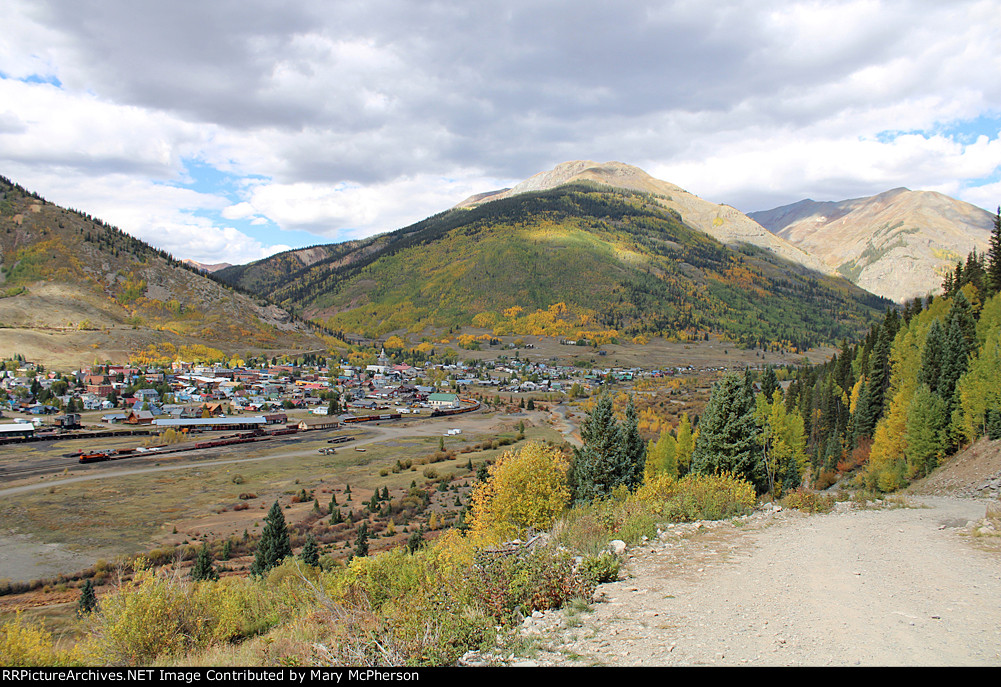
[786, 228, 1001, 492]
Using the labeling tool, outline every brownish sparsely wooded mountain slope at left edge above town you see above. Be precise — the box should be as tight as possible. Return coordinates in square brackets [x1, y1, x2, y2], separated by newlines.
[0, 177, 326, 366]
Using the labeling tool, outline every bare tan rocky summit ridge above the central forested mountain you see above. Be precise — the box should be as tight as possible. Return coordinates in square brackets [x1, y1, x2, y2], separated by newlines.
[456, 160, 832, 272]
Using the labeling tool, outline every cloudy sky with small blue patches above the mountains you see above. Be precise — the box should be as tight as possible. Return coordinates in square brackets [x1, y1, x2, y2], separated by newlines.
[0, 0, 1001, 262]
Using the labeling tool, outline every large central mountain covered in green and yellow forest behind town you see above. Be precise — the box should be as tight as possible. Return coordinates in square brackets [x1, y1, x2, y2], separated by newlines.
[218, 175, 887, 348]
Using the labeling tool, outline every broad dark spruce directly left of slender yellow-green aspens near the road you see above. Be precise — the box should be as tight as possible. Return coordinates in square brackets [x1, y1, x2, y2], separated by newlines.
[692, 373, 768, 492]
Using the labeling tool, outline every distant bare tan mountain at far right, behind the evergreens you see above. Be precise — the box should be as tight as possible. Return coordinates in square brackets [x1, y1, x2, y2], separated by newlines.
[748, 188, 994, 302]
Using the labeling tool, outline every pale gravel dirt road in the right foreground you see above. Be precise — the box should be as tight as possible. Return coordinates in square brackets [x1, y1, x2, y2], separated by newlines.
[525, 498, 1001, 666]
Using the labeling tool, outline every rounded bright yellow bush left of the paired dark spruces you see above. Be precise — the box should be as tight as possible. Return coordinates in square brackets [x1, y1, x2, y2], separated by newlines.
[471, 443, 570, 540]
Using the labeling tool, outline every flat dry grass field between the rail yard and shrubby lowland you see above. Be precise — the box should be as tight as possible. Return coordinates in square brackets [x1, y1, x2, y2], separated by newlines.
[0, 425, 560, 584]
